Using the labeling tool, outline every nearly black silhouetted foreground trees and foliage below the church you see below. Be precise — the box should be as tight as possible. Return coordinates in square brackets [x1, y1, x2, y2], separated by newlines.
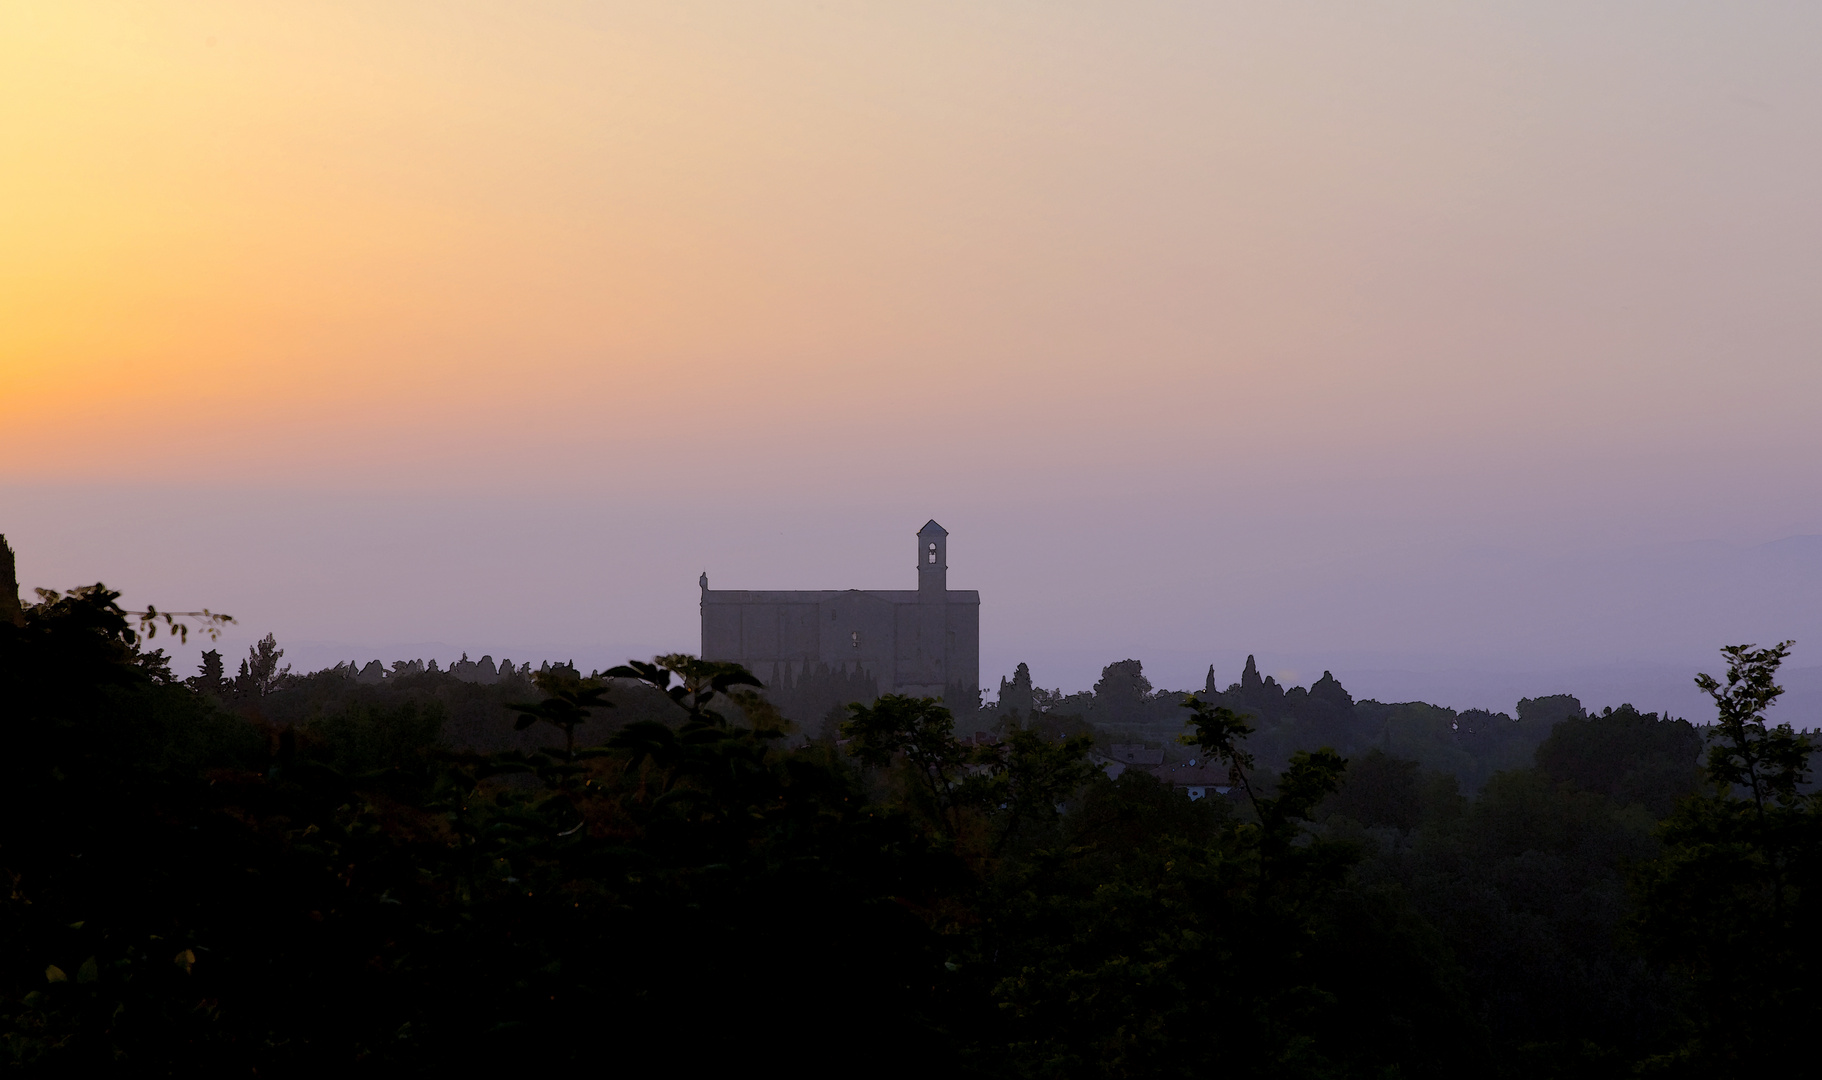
[0, 571, 1822, 1076]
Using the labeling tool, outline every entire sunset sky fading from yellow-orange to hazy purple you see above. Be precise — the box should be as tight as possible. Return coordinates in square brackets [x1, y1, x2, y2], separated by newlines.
[0, 0, 1822, 708]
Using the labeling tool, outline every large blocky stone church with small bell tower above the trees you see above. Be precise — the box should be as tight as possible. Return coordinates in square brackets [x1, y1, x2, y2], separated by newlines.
[701, 521, 980, 723]
